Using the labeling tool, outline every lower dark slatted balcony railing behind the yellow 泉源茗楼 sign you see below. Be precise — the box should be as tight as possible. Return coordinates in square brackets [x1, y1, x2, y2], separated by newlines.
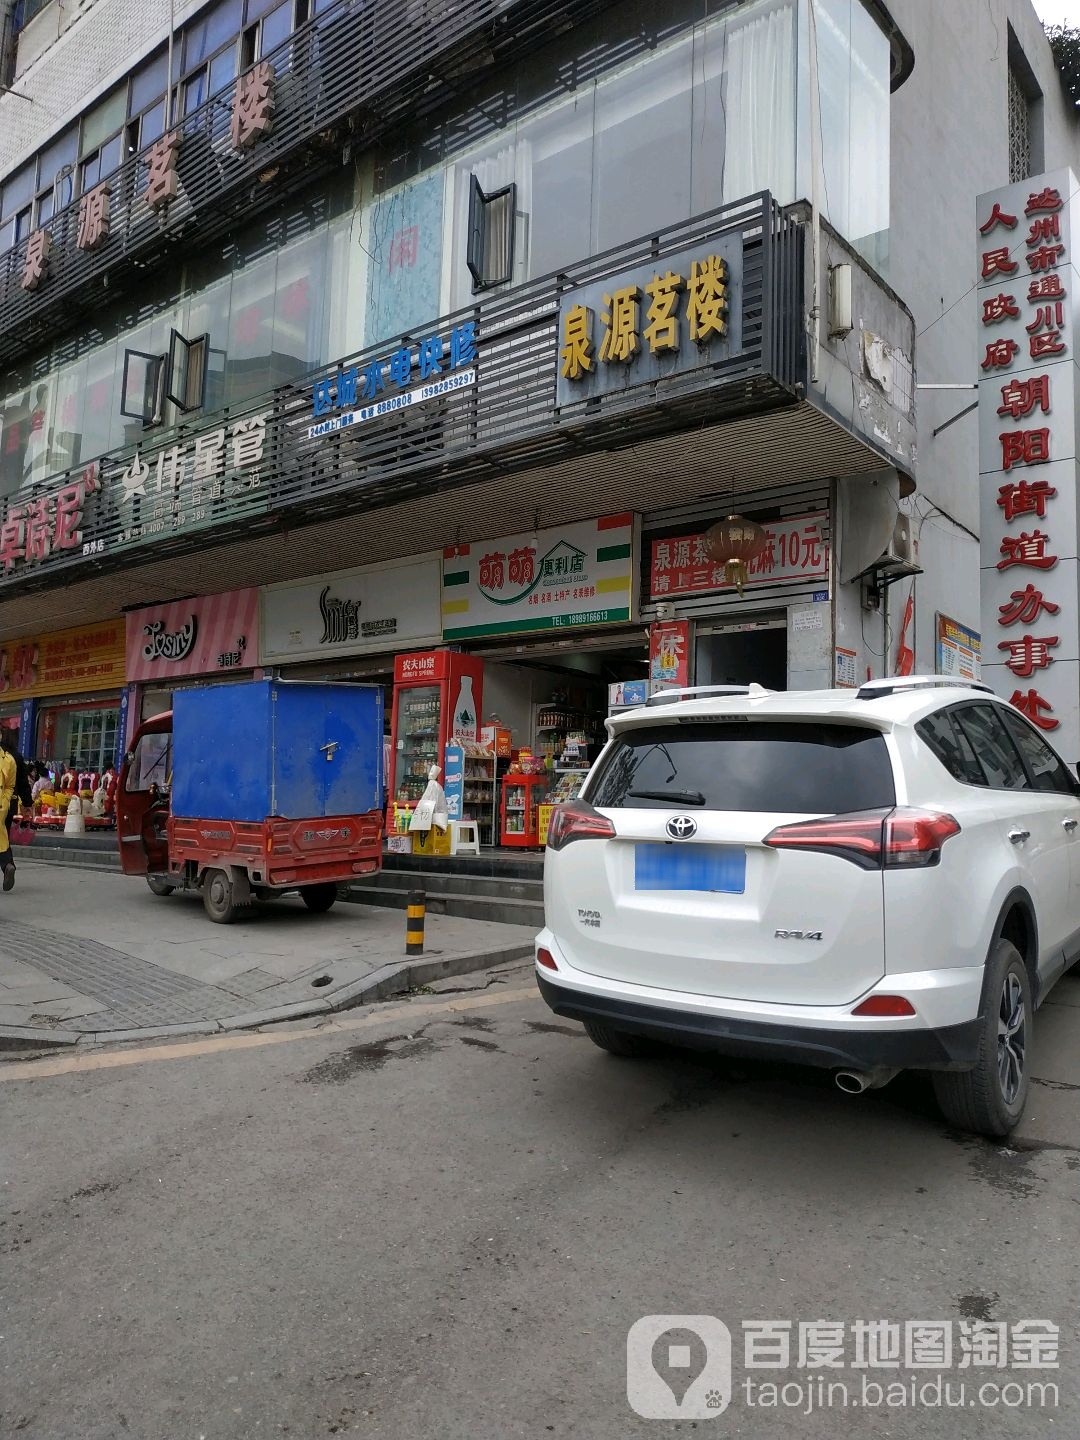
[0, 193, 805, 596]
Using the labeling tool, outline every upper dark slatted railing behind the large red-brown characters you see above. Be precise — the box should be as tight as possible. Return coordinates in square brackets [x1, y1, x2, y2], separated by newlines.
[0, 0, 613, 363]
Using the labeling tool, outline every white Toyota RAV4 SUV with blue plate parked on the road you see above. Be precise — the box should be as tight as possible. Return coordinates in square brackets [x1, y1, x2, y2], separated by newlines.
[536, 677, 1080, 1135]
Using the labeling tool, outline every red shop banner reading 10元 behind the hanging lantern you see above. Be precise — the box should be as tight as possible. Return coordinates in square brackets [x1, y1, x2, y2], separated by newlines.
[649, 516, 829, 600]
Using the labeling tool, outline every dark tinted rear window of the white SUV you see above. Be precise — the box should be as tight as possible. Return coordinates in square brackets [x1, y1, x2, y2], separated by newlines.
[585, 720, 896, 815]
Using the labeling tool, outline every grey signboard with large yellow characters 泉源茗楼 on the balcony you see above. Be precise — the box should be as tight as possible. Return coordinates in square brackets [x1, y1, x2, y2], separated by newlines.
[556, 235, 743, 406]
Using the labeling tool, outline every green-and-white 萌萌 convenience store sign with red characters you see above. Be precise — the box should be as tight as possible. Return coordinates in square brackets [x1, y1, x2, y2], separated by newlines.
[442, 514, 634, 641]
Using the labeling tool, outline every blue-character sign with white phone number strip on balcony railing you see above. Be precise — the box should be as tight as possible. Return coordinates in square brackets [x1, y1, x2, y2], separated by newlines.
[307, 321, 477, 439]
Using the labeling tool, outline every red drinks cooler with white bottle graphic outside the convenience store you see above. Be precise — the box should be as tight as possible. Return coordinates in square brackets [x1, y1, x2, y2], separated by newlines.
[386, 649, 484, 835]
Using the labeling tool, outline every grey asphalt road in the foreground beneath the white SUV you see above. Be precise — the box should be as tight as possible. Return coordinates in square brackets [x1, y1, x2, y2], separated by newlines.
[0, 969, 1080, 1440]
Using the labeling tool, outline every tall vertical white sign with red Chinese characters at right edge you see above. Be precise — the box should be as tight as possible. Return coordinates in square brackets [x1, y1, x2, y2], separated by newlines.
[975, 170, 1080, 763]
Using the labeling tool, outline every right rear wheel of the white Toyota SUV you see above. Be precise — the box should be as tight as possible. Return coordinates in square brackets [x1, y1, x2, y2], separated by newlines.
[933, 940, 1034, 1138]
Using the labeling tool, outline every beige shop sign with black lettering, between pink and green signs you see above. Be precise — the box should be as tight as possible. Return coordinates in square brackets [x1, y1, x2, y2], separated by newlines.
[262, 556, 441, 665]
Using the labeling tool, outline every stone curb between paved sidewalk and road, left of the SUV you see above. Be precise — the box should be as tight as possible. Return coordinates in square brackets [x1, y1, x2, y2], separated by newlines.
[0, 942, 533, 1063]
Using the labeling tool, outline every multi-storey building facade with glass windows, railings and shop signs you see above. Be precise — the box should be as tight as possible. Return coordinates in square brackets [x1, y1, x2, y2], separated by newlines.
[0, 0, 1076, 789]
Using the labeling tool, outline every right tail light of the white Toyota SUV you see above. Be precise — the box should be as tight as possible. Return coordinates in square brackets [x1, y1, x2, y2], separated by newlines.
[765, 809, 960, 870]
